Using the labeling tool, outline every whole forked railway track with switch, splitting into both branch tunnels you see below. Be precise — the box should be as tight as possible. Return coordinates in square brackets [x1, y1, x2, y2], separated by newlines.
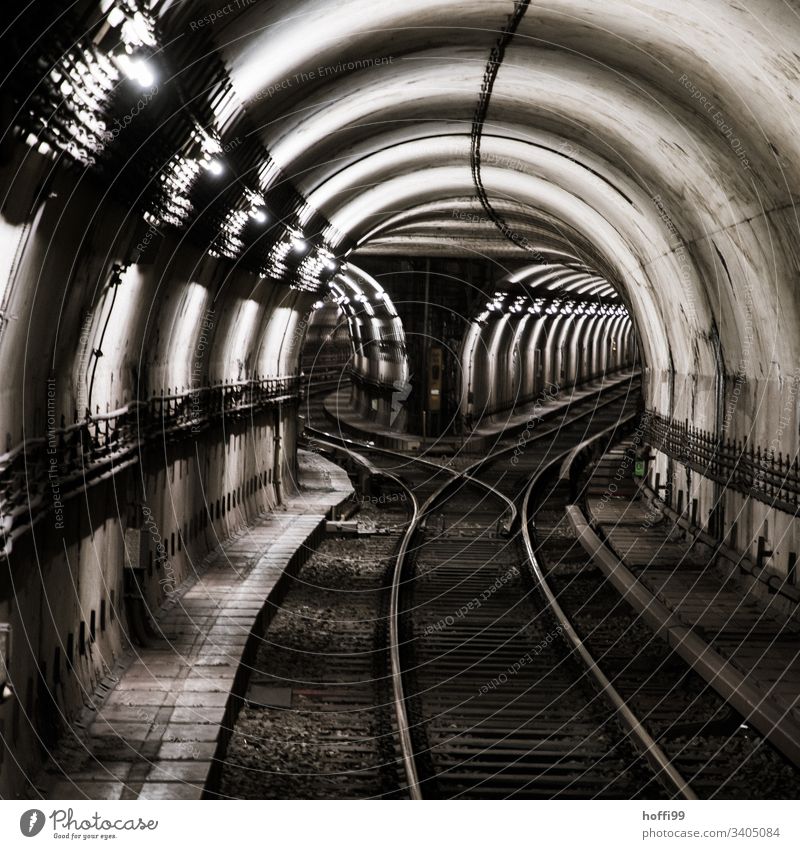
[227, 374, 788, 798]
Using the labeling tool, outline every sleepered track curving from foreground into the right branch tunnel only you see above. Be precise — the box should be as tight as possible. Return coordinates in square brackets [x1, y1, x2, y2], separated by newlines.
[399, 380, 691, 798]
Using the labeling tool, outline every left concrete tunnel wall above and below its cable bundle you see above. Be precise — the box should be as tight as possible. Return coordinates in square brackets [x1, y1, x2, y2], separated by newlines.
[0, 147, 311, 796]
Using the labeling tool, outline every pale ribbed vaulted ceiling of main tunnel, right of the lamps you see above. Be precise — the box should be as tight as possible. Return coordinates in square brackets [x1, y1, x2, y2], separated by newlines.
[189, 0, 800, 408]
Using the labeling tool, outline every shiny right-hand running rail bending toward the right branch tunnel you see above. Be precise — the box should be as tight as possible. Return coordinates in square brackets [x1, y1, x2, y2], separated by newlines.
[521, 432, 697, 799]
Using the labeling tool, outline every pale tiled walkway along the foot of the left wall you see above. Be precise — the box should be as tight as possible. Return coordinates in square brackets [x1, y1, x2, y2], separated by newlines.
[37, 452, 352, 799]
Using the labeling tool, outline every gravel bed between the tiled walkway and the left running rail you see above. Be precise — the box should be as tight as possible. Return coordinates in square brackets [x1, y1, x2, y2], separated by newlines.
[219, 458, 414, 799]
